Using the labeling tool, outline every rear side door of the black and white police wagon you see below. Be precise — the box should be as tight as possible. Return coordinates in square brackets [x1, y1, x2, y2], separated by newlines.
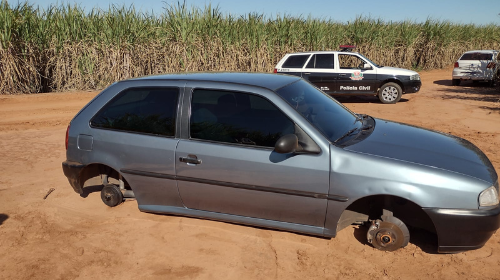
[302, 53, 337, 93]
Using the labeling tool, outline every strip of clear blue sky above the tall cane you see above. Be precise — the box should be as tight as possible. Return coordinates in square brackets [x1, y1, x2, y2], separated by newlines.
[29, 0, 500, 25]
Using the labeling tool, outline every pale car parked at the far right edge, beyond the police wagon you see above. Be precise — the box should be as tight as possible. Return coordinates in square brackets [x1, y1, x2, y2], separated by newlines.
[451, 50, 500, 86]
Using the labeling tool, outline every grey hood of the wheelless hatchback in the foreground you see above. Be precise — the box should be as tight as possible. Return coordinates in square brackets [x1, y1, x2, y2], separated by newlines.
[345, 119, 498, 184]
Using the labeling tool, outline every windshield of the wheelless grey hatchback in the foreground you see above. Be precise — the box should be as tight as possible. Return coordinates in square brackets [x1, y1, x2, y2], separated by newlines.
[276, 80, 361, 142]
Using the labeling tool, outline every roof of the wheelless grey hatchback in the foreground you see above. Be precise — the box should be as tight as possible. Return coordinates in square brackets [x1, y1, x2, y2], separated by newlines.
[127, 72, 300, 90]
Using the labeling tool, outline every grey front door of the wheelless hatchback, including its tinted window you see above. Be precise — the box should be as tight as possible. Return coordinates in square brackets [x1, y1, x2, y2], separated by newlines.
[176, 82, 329, 227]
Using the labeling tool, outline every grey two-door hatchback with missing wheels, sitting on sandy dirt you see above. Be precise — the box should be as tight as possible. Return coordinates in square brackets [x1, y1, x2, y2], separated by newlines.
[62, 73, 500, 252]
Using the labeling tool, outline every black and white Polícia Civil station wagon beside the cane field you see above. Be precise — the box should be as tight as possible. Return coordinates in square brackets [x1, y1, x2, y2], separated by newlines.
[274, 45, 422, 104]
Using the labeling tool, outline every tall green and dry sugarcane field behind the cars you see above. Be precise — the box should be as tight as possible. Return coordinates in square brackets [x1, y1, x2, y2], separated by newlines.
[0, 1, 500, 94]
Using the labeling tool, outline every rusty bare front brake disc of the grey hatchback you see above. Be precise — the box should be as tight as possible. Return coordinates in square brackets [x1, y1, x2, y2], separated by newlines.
[367, 216, 410, 252]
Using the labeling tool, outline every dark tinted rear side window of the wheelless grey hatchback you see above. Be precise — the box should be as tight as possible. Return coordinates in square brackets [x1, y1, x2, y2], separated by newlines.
[90, 88, 179, 136]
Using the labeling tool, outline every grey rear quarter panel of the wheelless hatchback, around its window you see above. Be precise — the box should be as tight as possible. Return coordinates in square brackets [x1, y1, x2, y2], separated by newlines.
[67, 81, 185, 209]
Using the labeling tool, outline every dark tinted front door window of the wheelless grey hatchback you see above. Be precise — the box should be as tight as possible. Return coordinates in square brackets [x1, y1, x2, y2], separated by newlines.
[190, 89, 294, 147]
